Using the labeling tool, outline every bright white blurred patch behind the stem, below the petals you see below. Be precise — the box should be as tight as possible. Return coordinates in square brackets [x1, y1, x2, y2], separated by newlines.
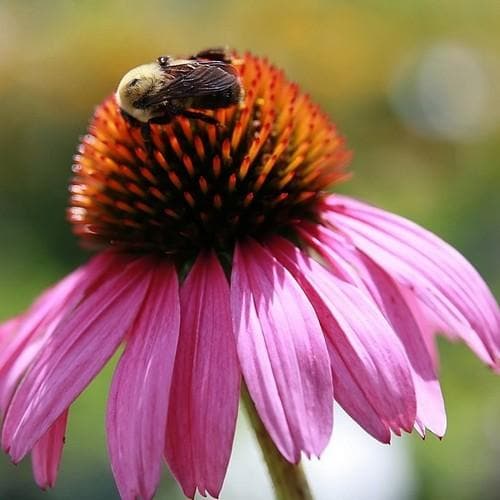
[220, 407, 416, 500]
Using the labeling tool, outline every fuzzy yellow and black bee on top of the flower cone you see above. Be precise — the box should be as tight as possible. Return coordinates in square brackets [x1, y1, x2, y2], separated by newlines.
[115, 48, 243, 147]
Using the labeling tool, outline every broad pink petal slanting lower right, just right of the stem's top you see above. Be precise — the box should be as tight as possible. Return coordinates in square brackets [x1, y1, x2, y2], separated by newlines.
[271, 238, 416, 442]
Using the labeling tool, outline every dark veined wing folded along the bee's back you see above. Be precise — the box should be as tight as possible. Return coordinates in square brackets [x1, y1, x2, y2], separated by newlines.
[144, 63, 236, 106]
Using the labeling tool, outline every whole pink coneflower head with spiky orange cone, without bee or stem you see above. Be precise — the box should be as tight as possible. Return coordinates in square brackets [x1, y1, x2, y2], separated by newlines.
[0, 54, 500, 499]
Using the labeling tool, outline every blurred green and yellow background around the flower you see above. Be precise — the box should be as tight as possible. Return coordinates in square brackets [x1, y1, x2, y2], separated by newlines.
[0, 0, 500, 500]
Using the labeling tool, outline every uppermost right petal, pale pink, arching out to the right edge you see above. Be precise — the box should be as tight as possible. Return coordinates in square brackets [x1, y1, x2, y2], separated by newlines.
[324, 196, 500, 365]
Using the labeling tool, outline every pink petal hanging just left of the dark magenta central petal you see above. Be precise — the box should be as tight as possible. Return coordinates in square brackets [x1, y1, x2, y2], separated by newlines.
[106, 262, 180, 500]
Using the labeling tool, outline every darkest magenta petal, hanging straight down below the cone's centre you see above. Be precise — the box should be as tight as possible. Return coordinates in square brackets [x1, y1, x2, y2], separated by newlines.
[165, 253, 240, 498]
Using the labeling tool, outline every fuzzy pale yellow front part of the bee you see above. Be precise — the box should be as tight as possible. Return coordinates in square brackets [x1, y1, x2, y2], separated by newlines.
[115, 63, 162, 123]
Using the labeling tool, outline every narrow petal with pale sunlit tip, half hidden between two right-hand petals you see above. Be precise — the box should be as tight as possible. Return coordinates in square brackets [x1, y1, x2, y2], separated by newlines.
[308, 228, 446, 436]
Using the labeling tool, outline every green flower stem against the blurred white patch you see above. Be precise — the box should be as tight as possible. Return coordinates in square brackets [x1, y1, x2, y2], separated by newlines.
[241, 386, 313, 500]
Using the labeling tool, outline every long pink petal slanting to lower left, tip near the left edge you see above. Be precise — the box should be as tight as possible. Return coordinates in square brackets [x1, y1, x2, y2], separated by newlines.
[2, 255, 151, 462]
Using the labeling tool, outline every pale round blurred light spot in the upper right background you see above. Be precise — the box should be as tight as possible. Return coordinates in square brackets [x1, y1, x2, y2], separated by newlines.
[389, 42, 500, 142]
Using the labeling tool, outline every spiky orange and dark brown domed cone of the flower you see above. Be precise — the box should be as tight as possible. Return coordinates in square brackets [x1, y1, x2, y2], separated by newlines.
[68, 54, 350, 257]
